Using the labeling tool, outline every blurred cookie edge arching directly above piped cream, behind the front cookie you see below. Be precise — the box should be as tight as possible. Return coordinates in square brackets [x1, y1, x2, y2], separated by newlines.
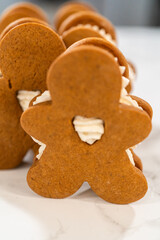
[58, 11, 116, 41]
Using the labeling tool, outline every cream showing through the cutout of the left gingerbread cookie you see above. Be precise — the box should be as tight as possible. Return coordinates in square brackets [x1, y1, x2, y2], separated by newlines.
[17, 90, 40, 111]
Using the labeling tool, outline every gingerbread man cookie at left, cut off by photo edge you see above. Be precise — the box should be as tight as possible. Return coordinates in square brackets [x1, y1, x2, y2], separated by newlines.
[0, 18, 65, 169]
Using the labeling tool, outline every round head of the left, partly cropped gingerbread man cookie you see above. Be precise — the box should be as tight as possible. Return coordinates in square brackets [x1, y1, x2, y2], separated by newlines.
[0, 19, 65, 91]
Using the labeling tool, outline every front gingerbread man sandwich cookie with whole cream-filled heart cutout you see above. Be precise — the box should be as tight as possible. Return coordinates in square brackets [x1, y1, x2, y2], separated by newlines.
[21, 40, 151, 204]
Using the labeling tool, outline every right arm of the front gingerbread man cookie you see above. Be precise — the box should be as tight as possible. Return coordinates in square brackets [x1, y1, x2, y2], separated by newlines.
[110, 104, 151, 149]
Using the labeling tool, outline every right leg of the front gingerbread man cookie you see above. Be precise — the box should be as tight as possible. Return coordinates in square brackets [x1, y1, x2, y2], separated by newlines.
[88, 153, 147, 204]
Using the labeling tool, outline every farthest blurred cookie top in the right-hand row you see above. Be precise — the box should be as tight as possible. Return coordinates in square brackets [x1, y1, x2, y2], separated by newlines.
[54, 2, 94, 31]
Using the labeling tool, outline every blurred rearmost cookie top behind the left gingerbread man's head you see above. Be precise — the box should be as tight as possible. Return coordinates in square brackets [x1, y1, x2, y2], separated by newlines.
[0, 2, 47, 33]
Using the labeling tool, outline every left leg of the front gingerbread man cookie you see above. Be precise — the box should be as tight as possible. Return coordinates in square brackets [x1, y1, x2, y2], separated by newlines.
[27, 149, 83, 198]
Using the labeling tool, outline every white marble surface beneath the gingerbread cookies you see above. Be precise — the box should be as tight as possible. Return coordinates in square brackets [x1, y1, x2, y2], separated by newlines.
[0, 28, 160, 240]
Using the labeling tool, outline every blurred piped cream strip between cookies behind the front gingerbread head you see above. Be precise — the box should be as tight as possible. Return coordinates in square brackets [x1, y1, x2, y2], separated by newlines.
[68, 24, 116, 45]
